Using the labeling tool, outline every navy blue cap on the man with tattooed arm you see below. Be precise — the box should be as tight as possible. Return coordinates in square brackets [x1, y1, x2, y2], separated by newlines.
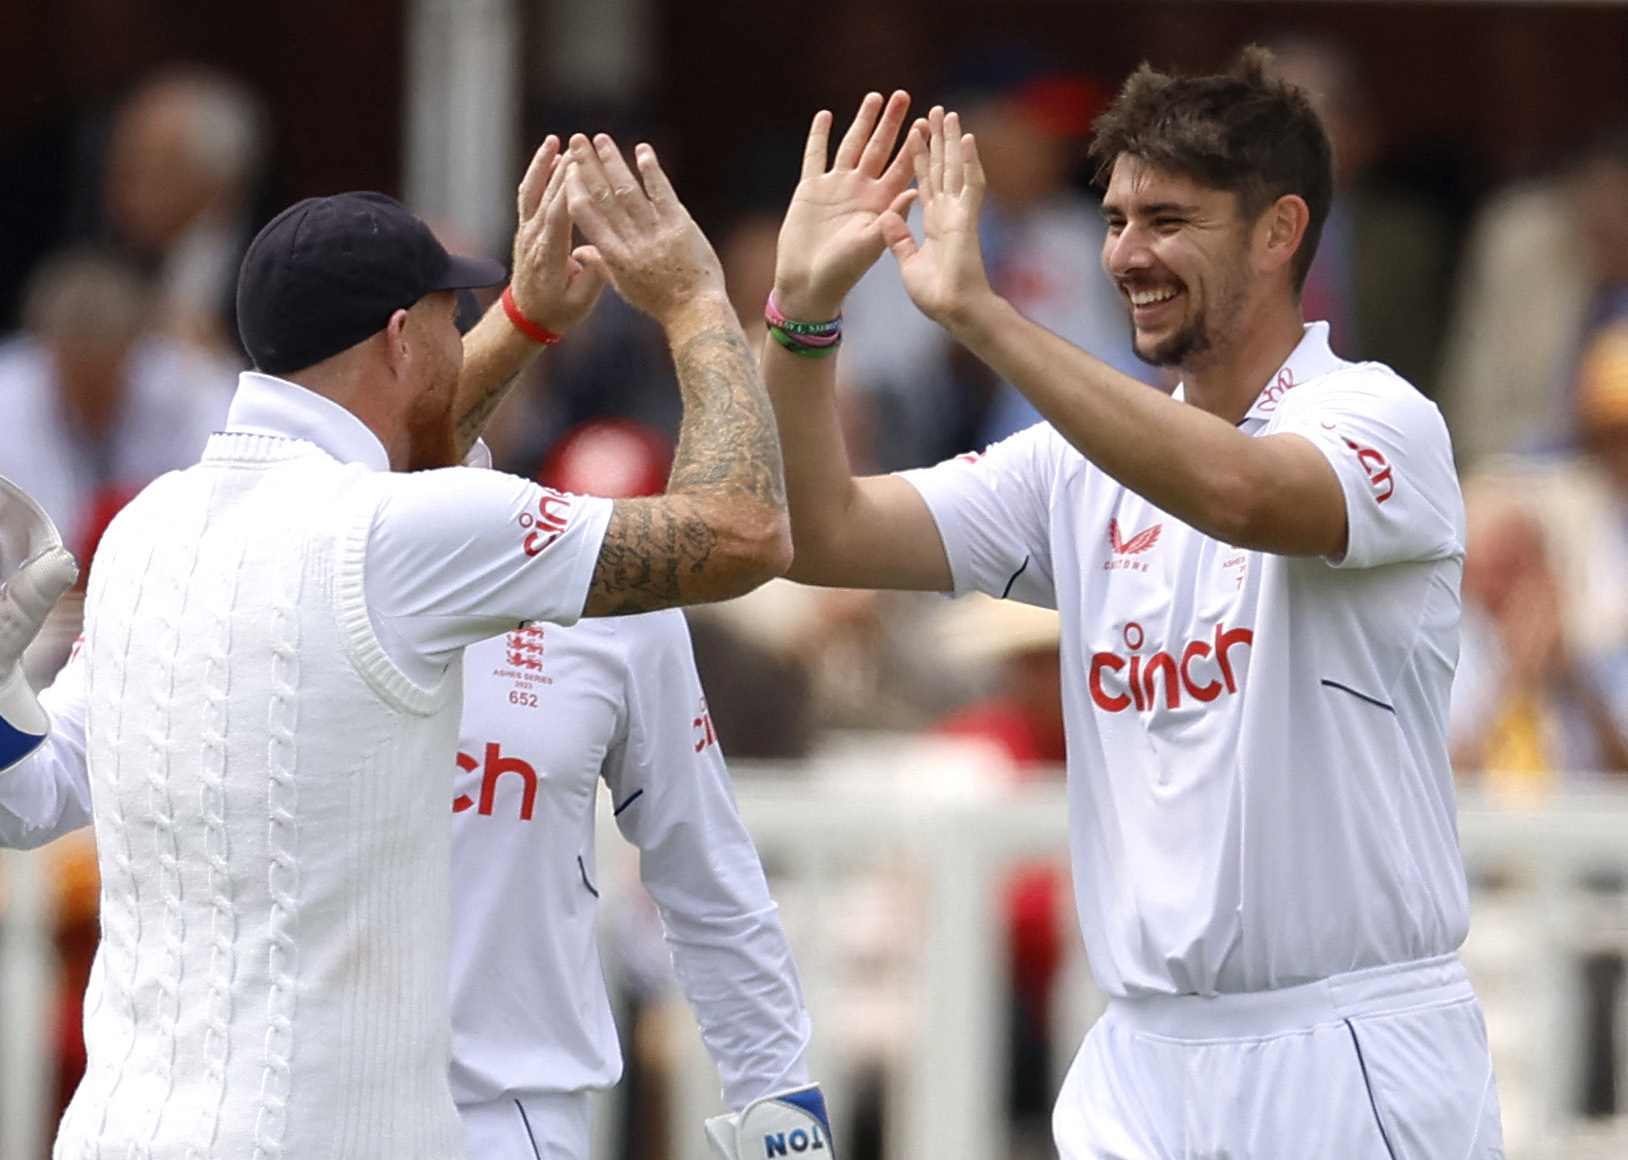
[238, 194, 508, 374]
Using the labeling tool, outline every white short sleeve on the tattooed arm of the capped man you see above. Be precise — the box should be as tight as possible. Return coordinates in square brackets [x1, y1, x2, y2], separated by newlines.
[366, 467, 612, 661]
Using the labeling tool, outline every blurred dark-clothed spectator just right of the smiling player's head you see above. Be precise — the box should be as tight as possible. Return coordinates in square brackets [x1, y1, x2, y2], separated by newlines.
[1267, 34, 1454, 397]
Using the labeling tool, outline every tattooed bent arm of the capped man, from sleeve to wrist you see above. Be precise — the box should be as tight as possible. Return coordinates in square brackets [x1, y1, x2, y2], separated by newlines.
[588, 325, 786, 615]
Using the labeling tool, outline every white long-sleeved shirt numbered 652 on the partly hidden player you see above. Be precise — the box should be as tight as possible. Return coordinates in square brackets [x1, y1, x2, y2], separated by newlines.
[451, 610, 809, 1108]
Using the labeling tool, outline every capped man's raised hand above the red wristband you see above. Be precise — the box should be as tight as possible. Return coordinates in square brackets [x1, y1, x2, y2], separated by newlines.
[510, 133, 604, 334]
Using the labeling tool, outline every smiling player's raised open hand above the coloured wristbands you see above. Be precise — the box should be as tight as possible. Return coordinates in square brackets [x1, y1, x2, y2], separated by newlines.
[775, 91, 921, 319]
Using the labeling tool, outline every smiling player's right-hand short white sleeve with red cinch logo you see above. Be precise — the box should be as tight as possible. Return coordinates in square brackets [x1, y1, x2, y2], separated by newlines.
[1270, 364, 1464, 568]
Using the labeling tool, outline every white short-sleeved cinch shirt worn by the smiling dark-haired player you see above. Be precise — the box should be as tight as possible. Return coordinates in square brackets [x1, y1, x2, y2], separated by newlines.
[904, 322, 1468, 996]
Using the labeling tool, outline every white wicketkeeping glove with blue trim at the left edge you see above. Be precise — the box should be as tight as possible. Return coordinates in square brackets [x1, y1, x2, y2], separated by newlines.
[0, 477, 80, 770]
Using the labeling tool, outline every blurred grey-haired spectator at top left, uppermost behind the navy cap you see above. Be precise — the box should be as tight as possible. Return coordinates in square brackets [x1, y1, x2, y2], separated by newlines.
[101, 67, 267, 358]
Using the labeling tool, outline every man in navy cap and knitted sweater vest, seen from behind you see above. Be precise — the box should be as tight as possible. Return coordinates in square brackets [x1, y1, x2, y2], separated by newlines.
[38, 137, 790, 1160]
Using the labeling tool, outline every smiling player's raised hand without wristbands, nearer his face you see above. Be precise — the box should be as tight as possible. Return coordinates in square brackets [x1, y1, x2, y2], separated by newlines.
[877, 107, 993, 325]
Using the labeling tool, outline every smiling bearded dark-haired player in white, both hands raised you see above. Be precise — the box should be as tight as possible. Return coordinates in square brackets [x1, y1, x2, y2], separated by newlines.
[764, 65, 1503, 1160]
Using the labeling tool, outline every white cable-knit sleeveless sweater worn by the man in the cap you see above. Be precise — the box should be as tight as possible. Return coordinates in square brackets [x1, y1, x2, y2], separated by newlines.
[55, 433, 464, 1160]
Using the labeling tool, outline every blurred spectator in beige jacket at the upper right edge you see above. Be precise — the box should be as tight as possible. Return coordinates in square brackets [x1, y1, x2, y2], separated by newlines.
[1441, 125, 1628, 469]
